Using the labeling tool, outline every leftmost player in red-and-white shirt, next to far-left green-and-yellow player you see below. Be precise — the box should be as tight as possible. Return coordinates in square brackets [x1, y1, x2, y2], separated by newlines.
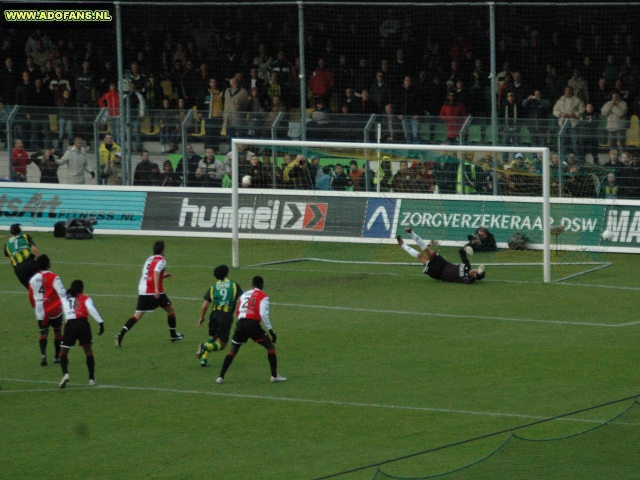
[29, 255, 67, 367]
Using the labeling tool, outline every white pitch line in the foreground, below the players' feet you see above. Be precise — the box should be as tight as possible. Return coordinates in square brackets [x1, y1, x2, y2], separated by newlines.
[0, 378, 636, 425]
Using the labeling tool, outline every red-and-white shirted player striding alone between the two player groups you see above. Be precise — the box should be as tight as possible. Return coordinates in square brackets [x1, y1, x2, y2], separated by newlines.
[115, 240, 184, 347]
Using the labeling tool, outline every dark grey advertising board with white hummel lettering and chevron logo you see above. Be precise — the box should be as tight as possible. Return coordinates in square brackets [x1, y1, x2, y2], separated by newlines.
[142, 192, 367, 238]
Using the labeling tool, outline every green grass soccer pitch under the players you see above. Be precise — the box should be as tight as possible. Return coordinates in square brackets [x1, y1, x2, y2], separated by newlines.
[0, 233, 640, 480]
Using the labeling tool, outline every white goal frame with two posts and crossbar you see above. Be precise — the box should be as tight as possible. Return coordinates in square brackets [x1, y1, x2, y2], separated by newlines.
[231, 138, 551, 283]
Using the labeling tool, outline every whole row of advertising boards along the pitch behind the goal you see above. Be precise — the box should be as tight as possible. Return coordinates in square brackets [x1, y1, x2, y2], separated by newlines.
[0, 185, 640, 248]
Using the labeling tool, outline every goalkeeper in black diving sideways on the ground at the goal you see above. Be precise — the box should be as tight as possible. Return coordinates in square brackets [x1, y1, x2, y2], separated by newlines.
[397, 228, 485, 285]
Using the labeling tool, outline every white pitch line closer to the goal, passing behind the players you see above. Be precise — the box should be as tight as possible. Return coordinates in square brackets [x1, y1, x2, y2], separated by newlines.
[0, 291, 640, 328]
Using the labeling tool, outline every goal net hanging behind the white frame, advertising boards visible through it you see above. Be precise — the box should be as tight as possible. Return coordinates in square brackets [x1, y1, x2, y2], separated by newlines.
[231, 139, 608, 282]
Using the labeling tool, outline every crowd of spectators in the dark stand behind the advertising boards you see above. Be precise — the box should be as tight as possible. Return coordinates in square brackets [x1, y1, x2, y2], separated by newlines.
[0, 6, 640, 198]
